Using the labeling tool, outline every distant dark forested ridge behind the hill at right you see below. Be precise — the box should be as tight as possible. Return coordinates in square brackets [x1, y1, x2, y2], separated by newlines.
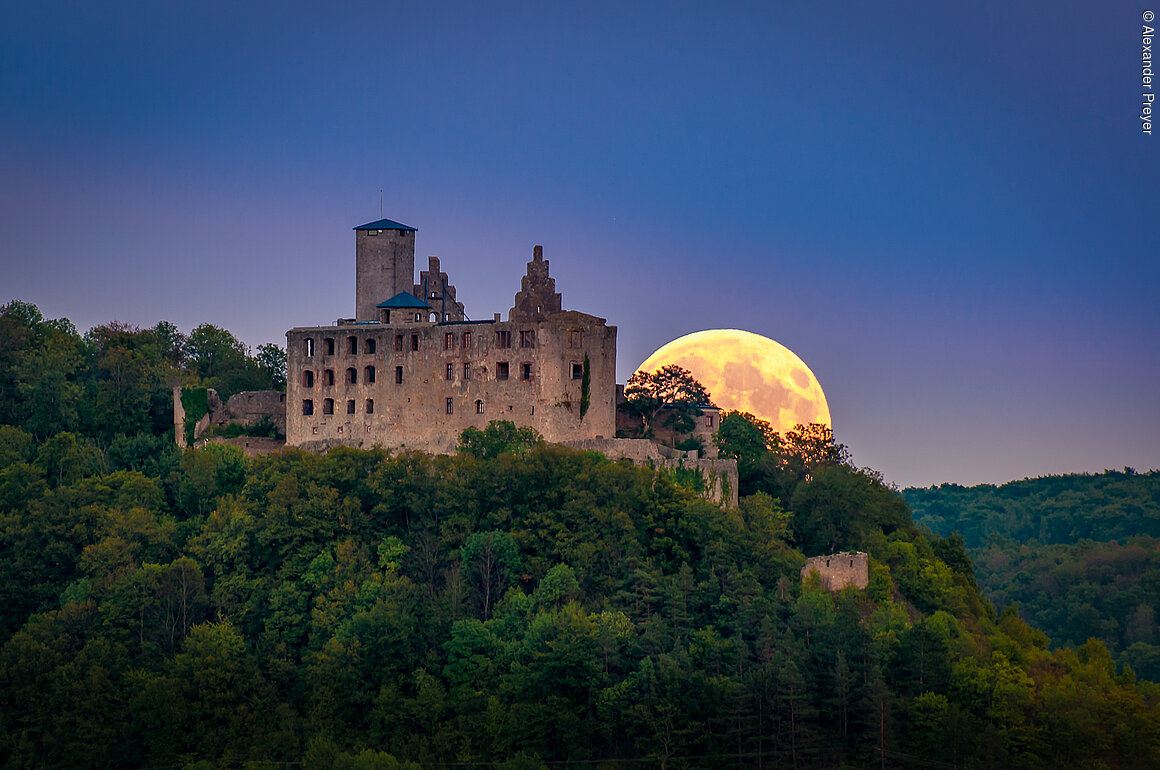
[904, 470, 1160, 681]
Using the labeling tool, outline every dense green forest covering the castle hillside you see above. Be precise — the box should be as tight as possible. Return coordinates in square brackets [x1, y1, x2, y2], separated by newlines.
[0, 305, 1160, 769]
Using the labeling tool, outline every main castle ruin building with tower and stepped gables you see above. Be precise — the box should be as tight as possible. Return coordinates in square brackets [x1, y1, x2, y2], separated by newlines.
[287, 219, 616, 452]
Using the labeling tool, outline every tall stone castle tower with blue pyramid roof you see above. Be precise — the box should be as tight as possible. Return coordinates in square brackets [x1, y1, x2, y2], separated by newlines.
[355, 219, 416, 321]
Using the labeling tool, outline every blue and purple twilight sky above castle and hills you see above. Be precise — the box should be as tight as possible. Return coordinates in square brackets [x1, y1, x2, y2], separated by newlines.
[0, 0, 1160, 486]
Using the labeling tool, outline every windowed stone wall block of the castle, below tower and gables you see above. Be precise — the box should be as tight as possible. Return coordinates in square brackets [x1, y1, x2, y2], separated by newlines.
[287, 312, 616, 452]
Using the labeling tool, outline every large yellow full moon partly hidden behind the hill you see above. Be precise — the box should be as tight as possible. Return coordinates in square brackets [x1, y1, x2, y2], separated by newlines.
[637, 329, 831, 433]
